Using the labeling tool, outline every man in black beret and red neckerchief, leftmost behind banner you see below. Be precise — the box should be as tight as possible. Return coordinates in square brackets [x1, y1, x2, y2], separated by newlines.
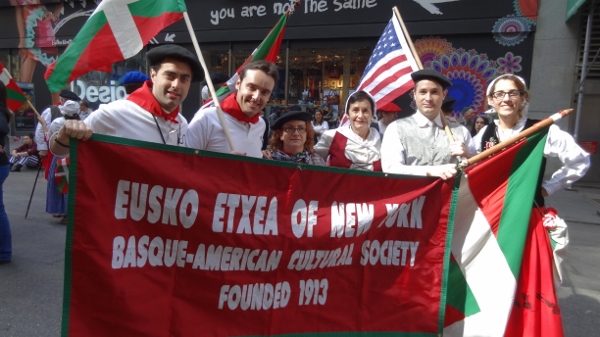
[50, 44, 204, 156]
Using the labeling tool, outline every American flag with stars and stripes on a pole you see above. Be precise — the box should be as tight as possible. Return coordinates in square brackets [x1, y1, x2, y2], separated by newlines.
[340, 15, 419, 125]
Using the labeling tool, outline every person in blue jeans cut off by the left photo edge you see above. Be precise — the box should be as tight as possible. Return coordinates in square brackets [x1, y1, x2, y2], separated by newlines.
[0, 81, 12, 264]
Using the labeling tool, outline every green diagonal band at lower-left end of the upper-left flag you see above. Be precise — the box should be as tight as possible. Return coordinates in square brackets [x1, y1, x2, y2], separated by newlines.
[46, 12, 107, 92]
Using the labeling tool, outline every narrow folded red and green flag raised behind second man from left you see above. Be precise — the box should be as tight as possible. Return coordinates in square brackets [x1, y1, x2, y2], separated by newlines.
[202, 8, 299, 108]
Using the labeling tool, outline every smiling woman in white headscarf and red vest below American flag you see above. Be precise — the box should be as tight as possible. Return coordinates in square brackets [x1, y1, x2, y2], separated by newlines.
[315, 90, 381, 171]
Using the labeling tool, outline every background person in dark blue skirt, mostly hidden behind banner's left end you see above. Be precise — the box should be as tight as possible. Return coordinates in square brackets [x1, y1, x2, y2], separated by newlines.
[46, 101, 80, 224]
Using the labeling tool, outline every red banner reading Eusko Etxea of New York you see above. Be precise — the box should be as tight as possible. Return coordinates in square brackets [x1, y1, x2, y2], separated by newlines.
[63, 135, 454, 336]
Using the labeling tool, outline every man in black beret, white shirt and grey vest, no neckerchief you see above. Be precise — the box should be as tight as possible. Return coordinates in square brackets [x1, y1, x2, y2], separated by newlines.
[381, 69, 475, 179]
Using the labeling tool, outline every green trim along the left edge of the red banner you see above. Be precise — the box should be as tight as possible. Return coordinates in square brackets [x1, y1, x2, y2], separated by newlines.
[61, 138, 78, 337]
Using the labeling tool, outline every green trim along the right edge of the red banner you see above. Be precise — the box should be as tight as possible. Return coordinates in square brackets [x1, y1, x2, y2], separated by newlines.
[438, 176, 467, 334]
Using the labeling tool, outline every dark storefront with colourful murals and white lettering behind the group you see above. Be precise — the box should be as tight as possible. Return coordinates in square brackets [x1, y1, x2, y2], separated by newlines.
[0, 0, 538, 122]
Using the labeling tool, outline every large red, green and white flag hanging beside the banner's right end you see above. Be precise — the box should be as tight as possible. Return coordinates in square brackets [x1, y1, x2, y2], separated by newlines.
[444, 128, 563, 337]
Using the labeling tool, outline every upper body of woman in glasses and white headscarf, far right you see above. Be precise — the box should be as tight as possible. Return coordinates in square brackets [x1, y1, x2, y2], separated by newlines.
[474, 74, 590, 200]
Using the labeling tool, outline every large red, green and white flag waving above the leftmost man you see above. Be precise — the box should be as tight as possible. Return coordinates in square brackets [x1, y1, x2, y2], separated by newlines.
[45, 0, 186, 92]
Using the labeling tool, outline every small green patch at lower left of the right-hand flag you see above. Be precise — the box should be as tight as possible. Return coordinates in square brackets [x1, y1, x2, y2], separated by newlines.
[447, 261, 481, 316]
